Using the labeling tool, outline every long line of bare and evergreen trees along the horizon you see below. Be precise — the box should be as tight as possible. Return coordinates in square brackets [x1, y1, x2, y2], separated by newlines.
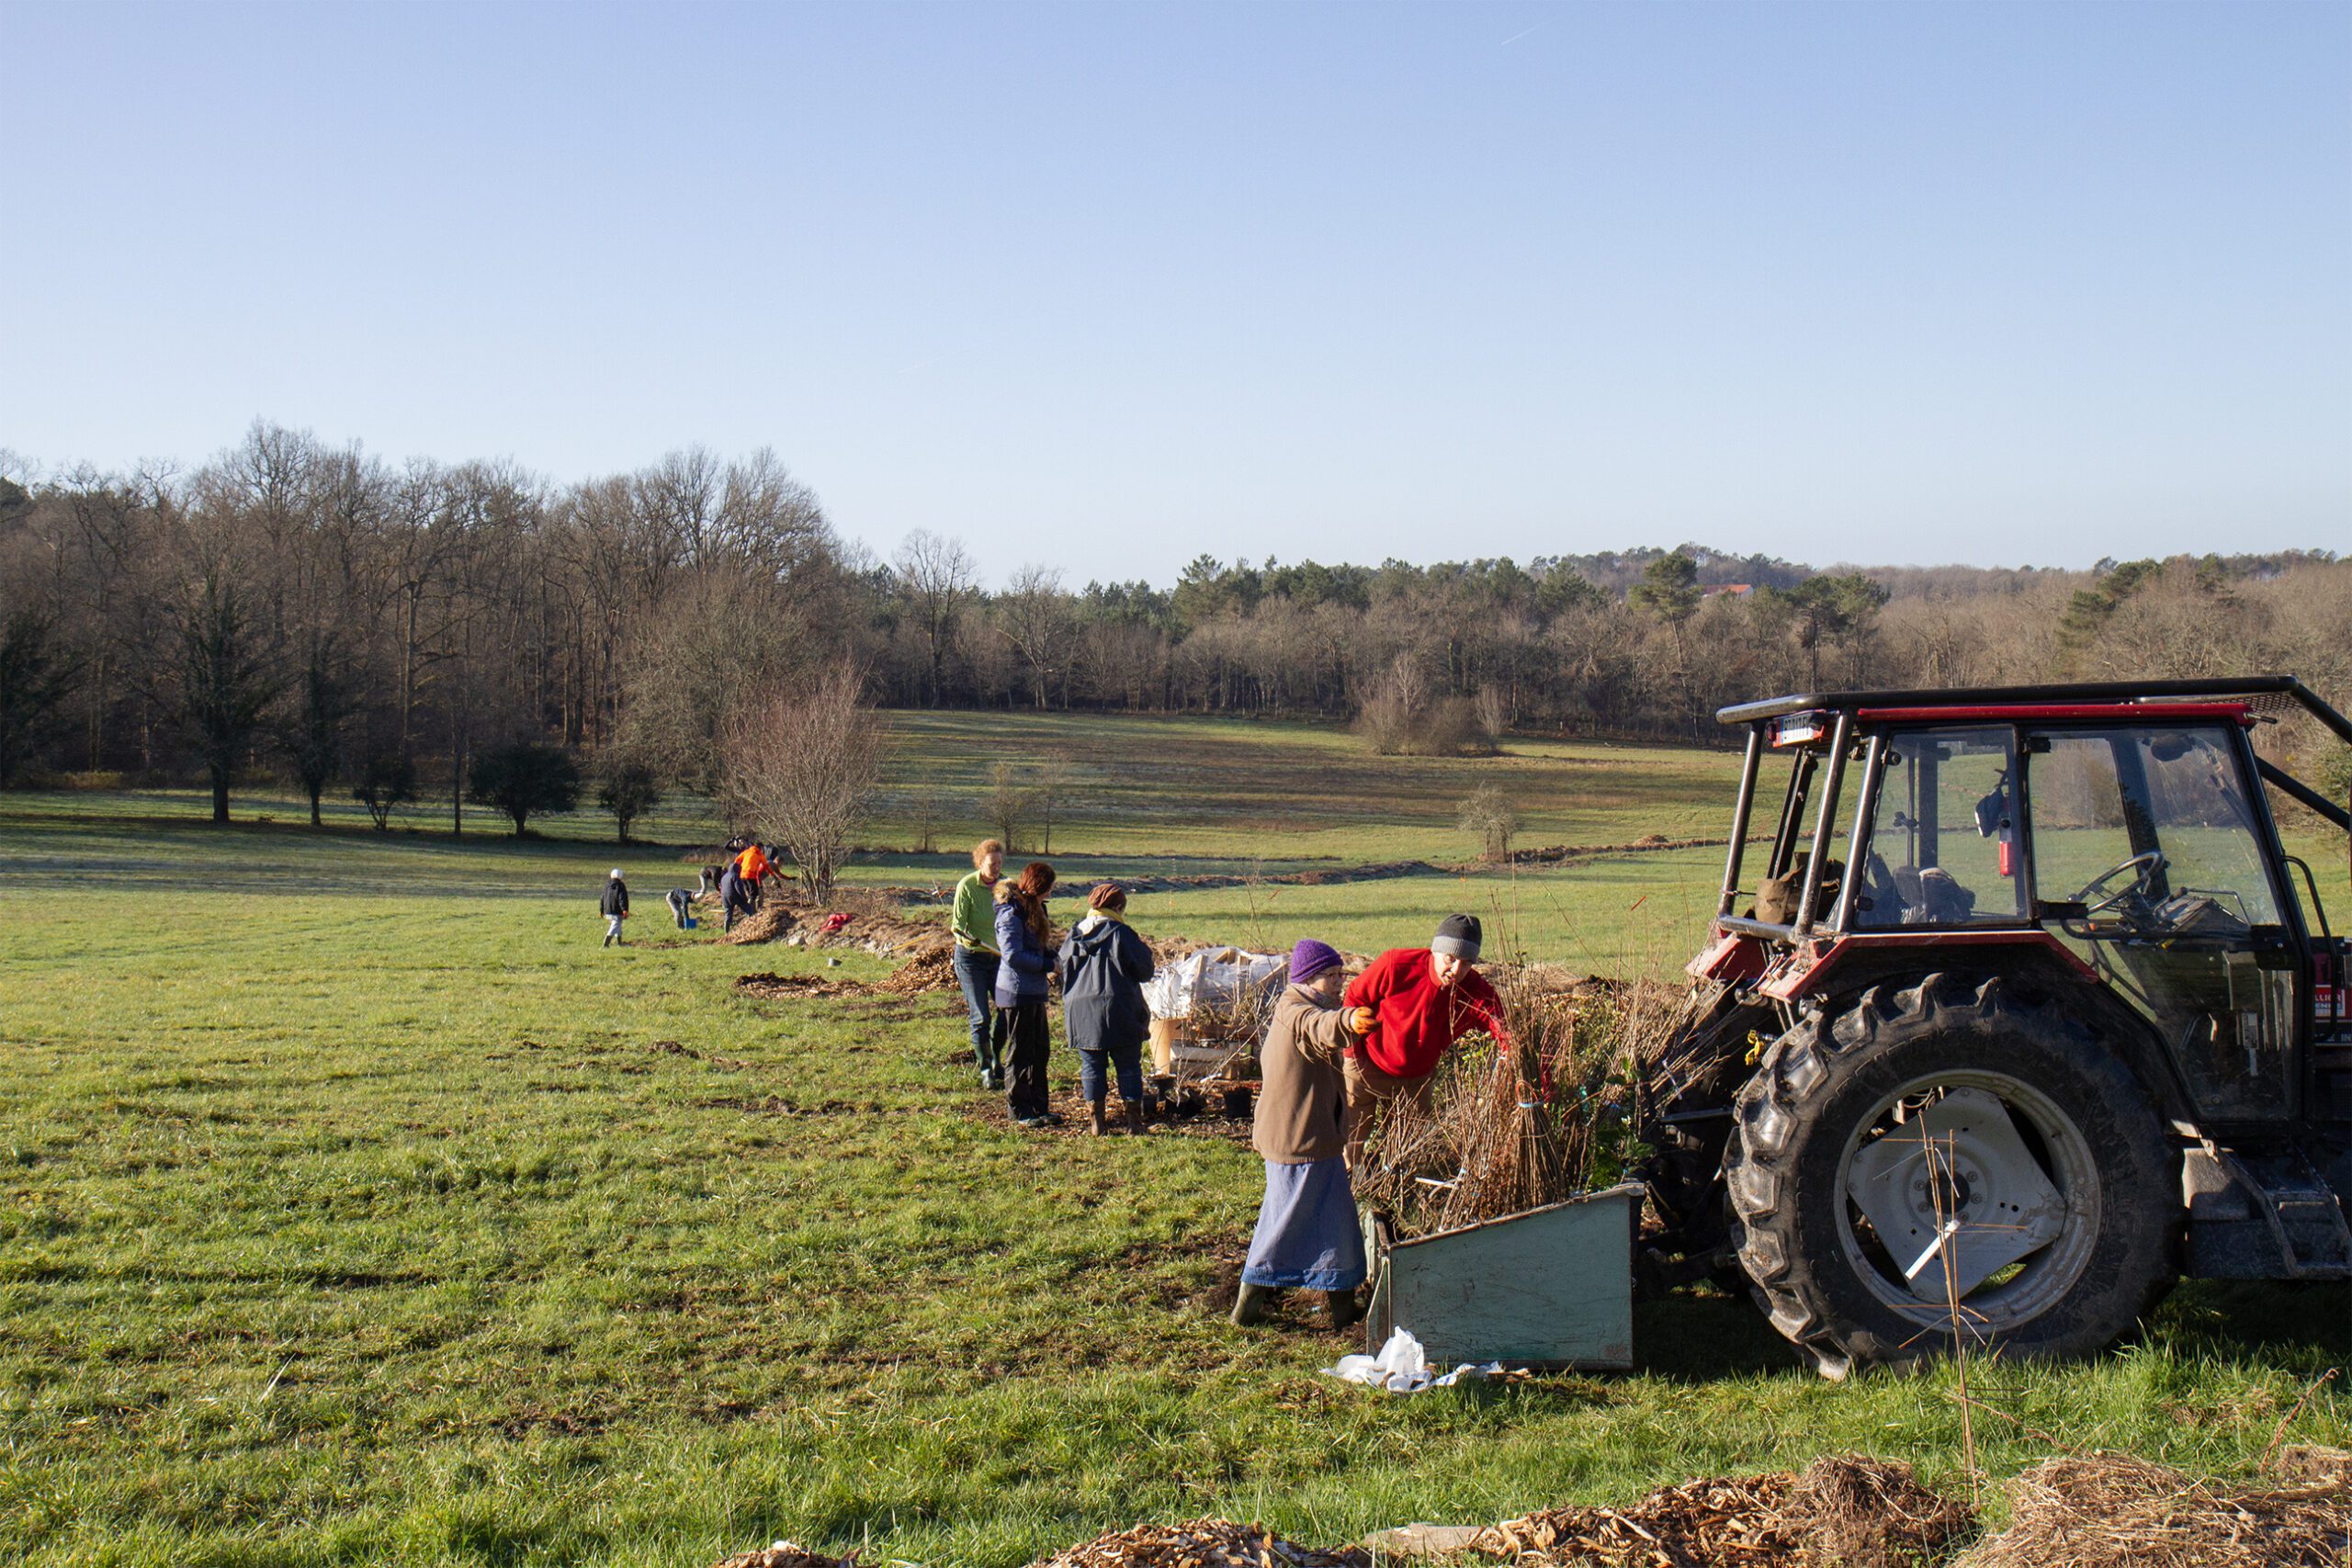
[0, 423, 2352, 832]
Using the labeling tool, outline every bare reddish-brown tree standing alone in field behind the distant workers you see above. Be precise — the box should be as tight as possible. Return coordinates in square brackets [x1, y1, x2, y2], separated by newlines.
[719, 665, 882, 903]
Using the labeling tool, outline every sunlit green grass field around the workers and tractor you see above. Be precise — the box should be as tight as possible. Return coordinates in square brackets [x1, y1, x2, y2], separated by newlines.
[0, 722, 2352, 1568]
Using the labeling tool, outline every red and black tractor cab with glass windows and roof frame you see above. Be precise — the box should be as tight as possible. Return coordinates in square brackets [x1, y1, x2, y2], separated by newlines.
[1693, 677, 2352, 1131]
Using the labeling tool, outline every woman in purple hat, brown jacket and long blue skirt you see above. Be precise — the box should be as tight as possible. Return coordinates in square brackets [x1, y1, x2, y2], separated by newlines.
[1232, 941, 1364, 1328]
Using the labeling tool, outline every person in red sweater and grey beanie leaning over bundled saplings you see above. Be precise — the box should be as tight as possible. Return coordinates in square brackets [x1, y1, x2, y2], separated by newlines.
[1343, 915, 1510, 1168]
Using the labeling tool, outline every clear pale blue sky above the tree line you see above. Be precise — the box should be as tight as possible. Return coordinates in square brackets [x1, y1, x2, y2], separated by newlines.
[0, 0, 2352, 585]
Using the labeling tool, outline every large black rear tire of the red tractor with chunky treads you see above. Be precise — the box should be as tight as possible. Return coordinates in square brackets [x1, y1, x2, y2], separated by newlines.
[1724, 976, 2183, 1378]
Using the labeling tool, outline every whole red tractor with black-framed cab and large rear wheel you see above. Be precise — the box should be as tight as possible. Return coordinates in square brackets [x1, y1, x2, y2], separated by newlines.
[1639, 677, 2352, 1378]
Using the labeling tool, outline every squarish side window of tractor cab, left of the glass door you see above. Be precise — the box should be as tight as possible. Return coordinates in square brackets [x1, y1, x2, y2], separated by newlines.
[1851, 727, 2025, 931]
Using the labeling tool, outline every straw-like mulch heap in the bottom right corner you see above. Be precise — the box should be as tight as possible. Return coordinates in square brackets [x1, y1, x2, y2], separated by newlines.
[1954, 1448, 2352, 1568]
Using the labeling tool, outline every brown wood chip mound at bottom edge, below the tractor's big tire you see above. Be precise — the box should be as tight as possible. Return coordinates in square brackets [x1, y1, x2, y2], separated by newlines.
[1470, 1455, 1973, 1568]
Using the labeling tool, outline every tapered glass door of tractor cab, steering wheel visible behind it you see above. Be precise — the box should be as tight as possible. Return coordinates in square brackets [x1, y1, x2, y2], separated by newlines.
[2025, 727, 2296, 1119]
